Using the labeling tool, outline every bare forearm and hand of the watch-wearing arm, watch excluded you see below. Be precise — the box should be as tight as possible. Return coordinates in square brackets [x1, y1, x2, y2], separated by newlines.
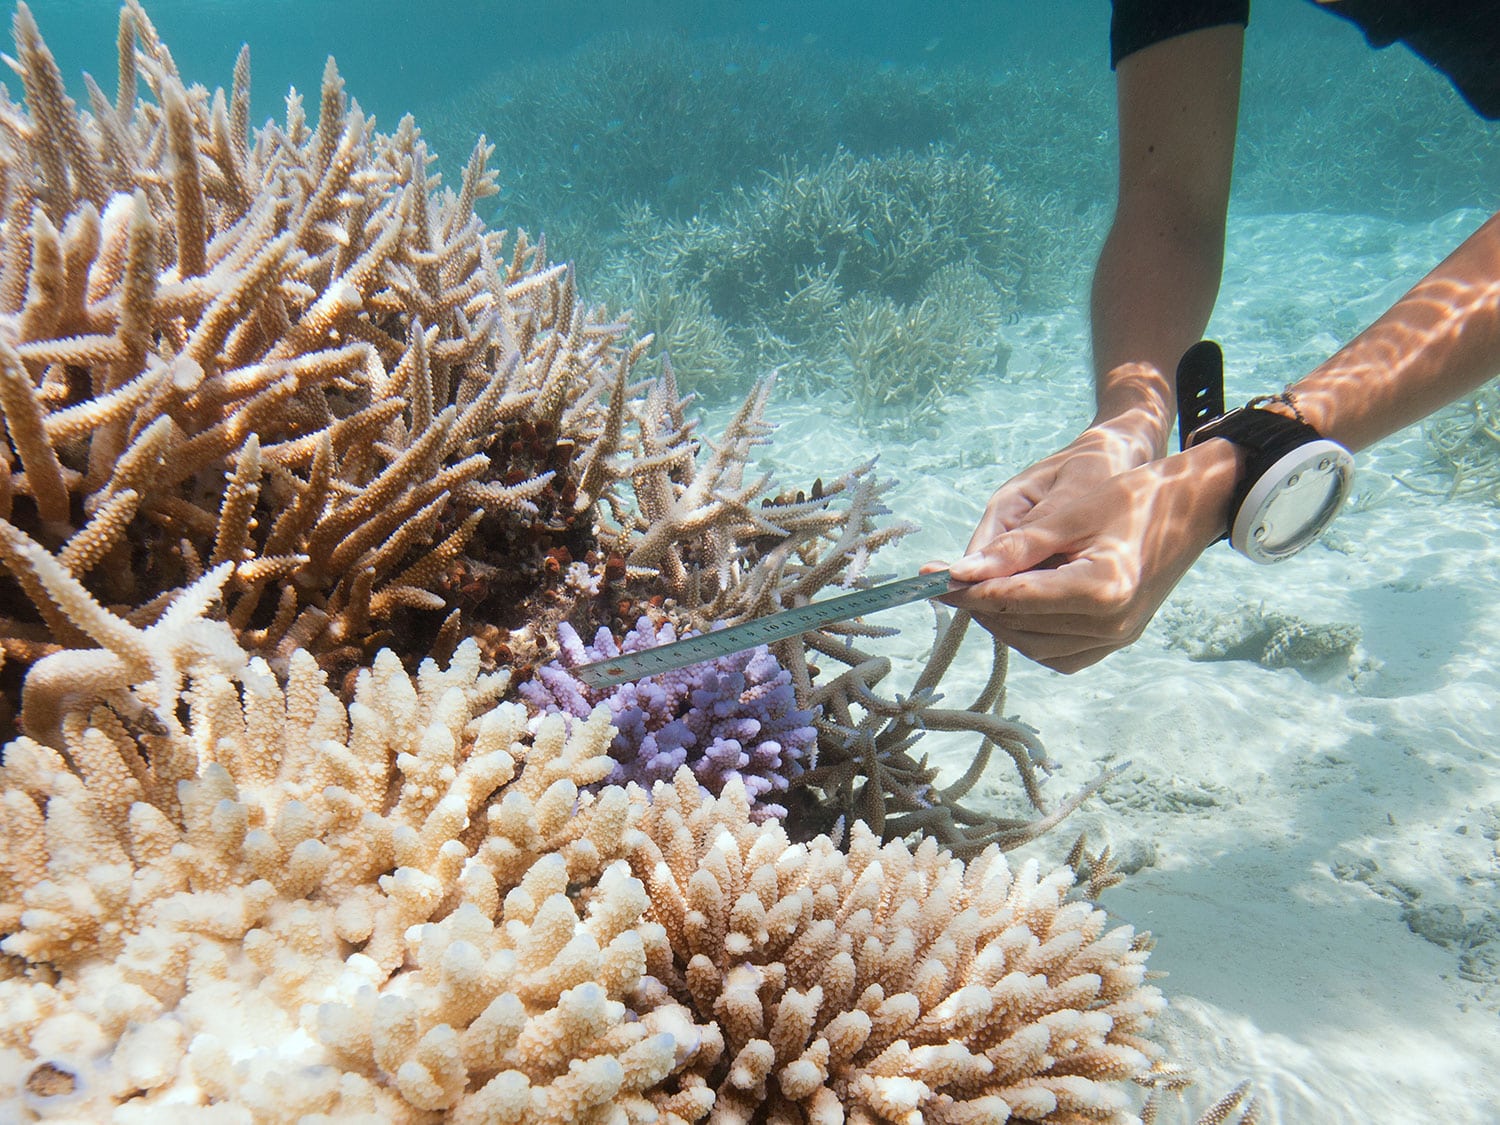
[948, 205, 1500, 672]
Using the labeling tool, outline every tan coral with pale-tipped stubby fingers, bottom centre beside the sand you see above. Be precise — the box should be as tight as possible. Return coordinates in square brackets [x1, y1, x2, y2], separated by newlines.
[632, 771, 1164, 1125]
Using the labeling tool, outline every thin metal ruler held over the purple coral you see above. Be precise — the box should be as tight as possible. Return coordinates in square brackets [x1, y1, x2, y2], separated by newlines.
[570, 570, 969, 689]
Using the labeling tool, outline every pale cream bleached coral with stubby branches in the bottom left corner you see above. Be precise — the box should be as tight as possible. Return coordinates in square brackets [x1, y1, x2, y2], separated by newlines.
[0, 642, 690, 1122]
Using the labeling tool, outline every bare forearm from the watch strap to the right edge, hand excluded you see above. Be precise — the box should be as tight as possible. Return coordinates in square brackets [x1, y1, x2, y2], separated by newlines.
[1292, 207, 1500, 449]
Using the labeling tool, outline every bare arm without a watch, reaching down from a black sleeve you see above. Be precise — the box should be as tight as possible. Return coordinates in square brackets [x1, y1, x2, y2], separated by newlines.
[971, 24, 1244, 549]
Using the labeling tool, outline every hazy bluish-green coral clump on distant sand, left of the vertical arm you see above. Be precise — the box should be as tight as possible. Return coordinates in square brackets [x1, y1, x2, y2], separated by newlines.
[596, 149, 1023, 425]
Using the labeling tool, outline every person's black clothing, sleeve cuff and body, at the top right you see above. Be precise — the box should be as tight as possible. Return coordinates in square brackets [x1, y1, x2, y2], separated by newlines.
[1110, 0, 1500, 120]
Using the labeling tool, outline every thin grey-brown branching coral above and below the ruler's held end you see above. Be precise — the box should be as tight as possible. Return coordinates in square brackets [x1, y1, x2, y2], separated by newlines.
[573, 365, 1109, 854]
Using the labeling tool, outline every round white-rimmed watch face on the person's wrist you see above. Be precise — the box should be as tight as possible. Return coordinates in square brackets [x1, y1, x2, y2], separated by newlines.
[1230, 440, 1355, 563]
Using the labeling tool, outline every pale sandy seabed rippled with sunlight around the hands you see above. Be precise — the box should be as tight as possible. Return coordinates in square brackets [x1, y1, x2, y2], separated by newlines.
[732, 213, 1500, 1125]
